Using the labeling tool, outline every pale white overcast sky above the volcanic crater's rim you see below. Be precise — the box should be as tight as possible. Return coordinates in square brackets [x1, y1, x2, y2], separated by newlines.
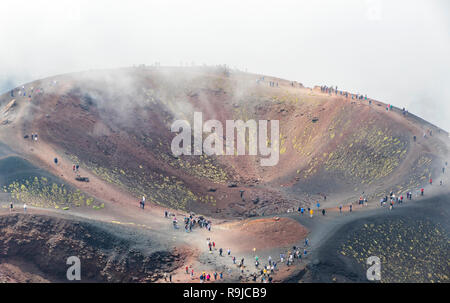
[0, 0, 450, 131]
